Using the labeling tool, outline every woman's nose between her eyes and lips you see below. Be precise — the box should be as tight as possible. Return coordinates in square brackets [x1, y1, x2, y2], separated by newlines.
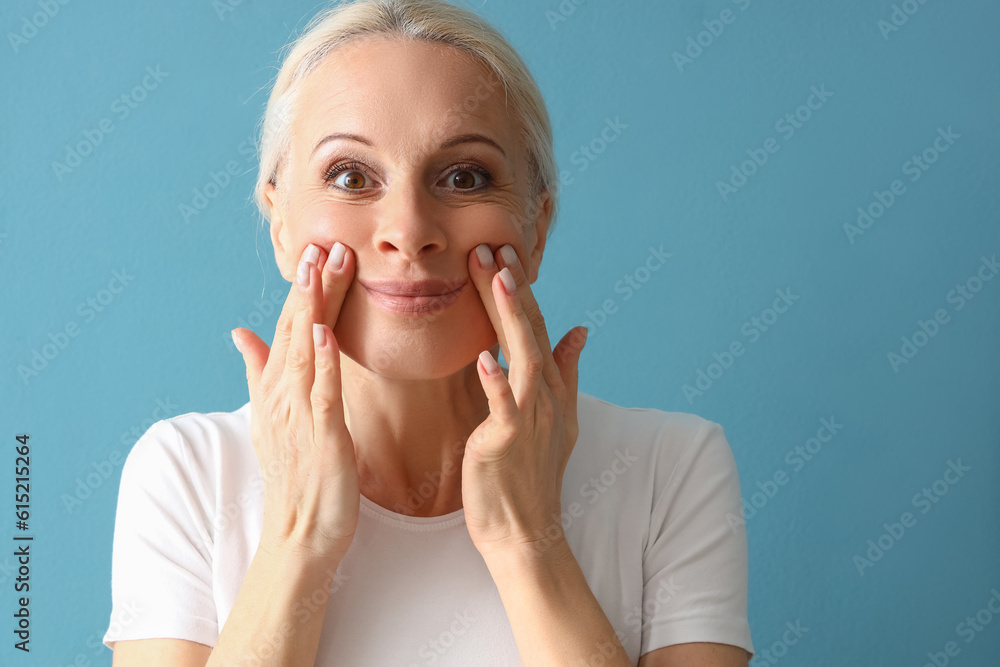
[374, 180, 447, 261]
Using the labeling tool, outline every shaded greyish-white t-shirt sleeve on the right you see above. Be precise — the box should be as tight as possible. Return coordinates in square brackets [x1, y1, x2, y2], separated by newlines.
[640, 420, 753, 657]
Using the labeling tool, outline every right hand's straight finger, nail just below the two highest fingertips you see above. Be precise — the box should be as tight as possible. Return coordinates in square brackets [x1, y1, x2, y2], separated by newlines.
[493, 267, 544, 406]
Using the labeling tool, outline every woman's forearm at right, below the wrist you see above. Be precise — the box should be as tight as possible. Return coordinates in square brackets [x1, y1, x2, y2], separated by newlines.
[487, 542, 634, 667]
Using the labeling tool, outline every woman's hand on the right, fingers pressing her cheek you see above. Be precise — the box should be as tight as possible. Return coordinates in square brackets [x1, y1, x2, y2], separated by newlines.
[462, 244, 587, 559]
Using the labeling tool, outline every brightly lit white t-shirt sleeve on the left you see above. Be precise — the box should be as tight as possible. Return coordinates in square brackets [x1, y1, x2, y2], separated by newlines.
[103, 420, 219, 649]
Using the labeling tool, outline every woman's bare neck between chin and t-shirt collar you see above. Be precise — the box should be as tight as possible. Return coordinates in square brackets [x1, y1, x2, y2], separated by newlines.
[340, 350, 496, 517]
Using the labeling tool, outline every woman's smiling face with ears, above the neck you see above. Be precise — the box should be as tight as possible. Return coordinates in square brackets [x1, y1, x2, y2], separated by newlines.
[267, 37, 551, 379]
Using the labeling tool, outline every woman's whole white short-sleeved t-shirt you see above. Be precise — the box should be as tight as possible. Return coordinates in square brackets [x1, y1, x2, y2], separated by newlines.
[104, 392, 753, 667]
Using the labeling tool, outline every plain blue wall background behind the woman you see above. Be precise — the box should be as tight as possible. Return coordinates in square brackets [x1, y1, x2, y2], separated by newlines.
[0, 0, 1000, 667]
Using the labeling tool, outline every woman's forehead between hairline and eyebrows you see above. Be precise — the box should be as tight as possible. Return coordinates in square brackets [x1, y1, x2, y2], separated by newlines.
[293, 36, 520, 159]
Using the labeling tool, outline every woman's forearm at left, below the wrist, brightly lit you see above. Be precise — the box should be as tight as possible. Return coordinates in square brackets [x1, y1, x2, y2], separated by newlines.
[205, 549, 338, 667]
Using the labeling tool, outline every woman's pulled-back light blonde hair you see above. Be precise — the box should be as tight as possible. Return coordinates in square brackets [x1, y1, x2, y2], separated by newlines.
[253, 0, 558, 233]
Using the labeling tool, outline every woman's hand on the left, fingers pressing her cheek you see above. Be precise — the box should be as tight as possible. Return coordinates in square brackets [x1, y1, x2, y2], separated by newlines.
[233, 243, 361, 561]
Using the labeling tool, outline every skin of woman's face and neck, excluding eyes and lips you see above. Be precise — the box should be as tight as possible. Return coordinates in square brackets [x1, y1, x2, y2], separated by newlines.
[268, 39, 551, 516]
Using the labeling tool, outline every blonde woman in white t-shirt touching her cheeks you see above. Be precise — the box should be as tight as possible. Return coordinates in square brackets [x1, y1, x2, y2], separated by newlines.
[104, 0, 753, 667]
